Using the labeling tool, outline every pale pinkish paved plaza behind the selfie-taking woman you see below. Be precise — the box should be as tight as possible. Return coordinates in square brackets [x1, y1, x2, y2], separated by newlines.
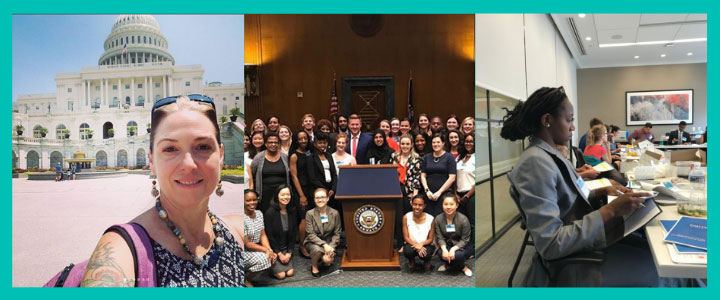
[12, 175, 243, 286]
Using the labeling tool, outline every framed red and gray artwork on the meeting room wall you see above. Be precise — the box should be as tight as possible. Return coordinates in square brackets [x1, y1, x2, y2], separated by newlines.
[625, 89, 693, 126]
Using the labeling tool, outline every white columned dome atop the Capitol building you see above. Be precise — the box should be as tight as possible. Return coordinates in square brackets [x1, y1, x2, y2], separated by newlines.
[98, 15, 175, 66]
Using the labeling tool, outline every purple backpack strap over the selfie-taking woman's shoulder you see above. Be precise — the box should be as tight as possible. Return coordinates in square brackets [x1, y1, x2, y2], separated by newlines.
[108, 223, 157, 287]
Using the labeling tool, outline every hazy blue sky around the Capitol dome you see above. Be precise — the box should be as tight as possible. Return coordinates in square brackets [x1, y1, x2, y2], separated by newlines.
[12, 15, 244, 102]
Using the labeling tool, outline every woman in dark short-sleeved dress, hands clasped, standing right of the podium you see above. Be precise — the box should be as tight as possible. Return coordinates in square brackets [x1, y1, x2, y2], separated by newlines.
[420, 133, 457, 216]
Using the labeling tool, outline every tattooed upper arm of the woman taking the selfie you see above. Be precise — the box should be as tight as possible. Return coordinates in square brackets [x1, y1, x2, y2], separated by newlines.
[81, 242, 135, 287]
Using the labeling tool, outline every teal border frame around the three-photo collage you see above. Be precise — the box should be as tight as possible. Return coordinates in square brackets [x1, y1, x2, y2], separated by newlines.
[0, 0, 720, 300]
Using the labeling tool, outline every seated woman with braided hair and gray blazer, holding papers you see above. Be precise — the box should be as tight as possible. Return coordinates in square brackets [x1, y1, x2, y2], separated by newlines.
[500, 87, 676, 286]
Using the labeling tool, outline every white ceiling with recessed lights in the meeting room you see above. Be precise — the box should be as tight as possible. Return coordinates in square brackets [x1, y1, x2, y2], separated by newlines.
[551, 14, 707, 69]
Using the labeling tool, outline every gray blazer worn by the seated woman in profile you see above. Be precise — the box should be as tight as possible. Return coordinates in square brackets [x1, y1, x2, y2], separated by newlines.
[508, 139, 622, 260]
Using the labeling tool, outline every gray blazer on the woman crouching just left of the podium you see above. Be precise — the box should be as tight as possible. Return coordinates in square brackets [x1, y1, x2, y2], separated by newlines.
[303, 206, 342, 248]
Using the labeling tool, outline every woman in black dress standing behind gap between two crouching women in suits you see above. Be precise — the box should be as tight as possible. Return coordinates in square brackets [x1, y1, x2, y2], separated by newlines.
[290, 130, 314, 257]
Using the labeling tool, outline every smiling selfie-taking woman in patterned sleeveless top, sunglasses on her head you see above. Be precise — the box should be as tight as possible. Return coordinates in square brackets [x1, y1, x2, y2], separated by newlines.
[81, 95, 245, 287]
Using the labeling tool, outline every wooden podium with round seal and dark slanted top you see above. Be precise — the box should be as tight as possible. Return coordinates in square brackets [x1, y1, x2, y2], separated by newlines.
[335, 165, 402, 270]
